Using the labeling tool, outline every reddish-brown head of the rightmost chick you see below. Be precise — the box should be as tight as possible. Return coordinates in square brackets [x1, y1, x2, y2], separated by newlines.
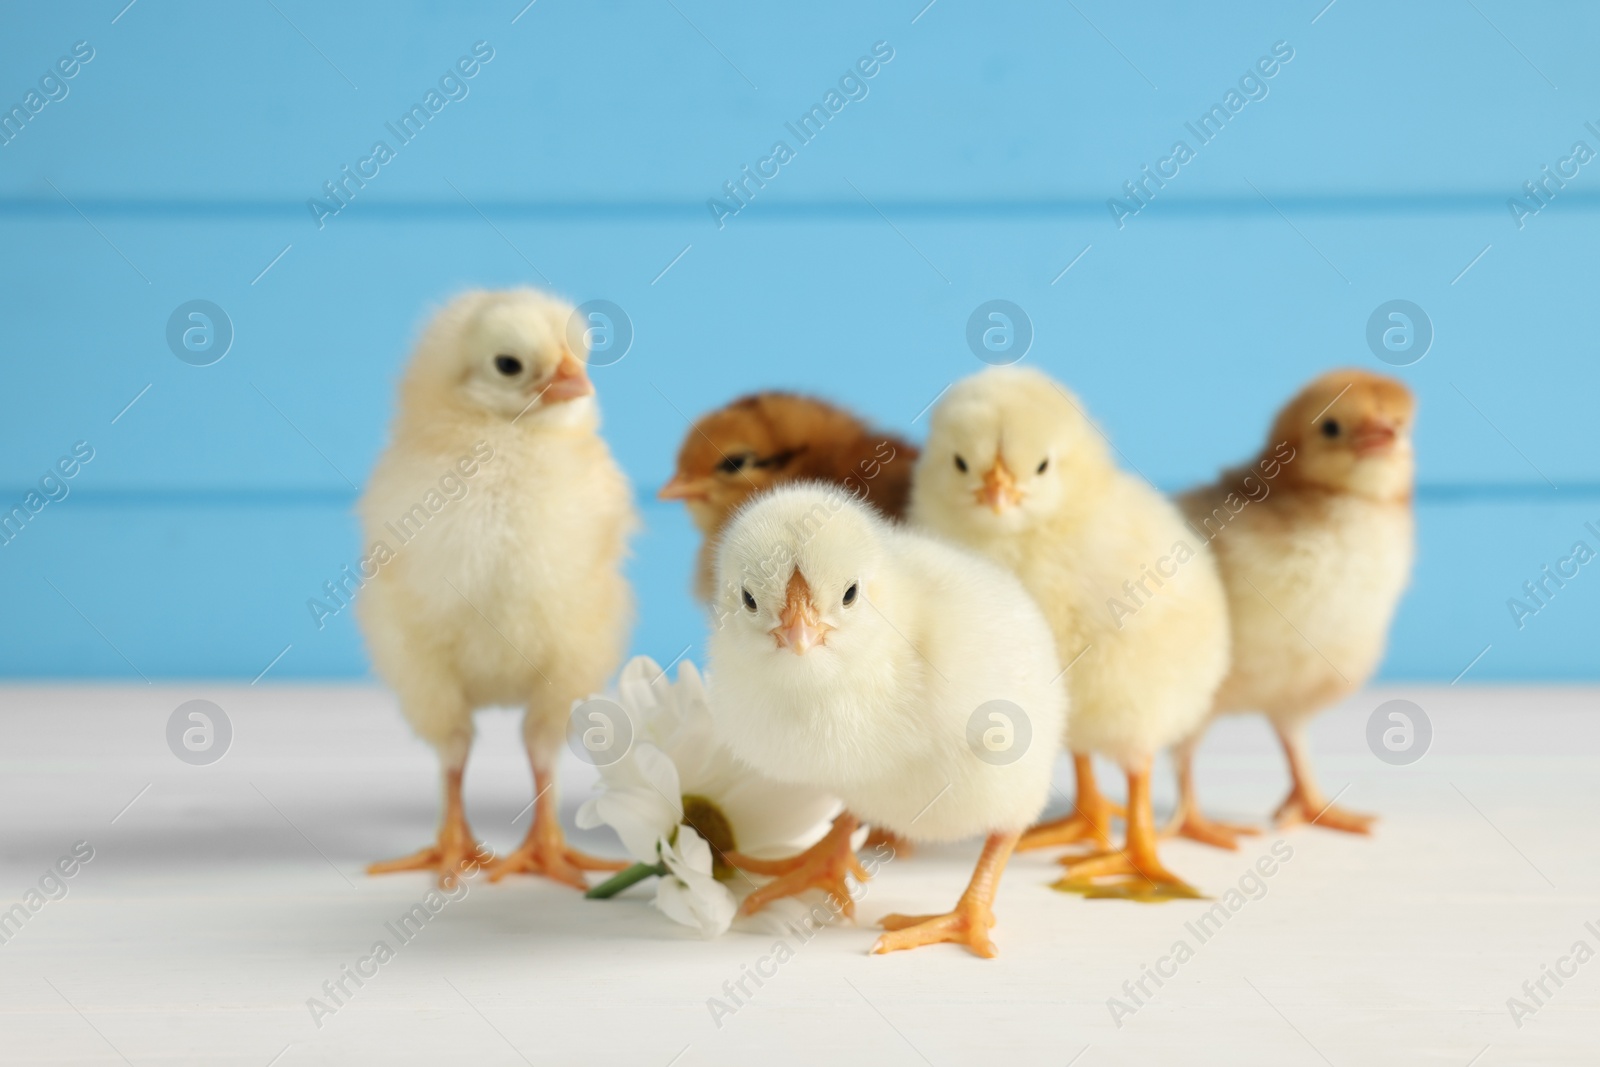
[1267, 370, 1416, 499]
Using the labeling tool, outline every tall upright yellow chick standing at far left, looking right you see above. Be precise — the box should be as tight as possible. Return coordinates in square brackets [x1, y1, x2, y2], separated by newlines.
[357, 290, 635, 888]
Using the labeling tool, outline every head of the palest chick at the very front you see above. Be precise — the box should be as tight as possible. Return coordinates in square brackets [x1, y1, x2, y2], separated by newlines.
[712, 483, 893, 681]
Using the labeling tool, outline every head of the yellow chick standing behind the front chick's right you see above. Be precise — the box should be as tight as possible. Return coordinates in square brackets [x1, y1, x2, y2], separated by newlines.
[912, 368, 1112, 539]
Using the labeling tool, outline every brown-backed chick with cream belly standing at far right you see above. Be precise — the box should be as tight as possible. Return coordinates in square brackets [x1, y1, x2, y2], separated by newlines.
[1174, 370, 1416, 848]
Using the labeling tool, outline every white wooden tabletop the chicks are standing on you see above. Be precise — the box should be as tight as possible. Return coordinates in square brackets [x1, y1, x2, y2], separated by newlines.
[0, 685, 1600, 1067]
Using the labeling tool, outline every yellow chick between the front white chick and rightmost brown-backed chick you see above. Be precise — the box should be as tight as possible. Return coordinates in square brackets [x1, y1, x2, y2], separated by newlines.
[910, 368, 1229, 899]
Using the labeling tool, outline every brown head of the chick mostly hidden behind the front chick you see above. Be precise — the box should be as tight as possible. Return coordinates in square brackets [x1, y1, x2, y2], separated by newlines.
[659, 392, 862, 533]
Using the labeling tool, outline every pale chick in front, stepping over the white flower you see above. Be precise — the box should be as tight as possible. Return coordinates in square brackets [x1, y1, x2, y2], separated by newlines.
[709, 483, 1066, 957]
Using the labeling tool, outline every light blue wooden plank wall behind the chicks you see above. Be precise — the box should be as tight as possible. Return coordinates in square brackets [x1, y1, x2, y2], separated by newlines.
[0, 0, 1600, 681]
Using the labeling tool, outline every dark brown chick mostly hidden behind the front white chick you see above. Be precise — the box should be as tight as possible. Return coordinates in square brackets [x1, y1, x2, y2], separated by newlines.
[658, 392, 917, 601]
